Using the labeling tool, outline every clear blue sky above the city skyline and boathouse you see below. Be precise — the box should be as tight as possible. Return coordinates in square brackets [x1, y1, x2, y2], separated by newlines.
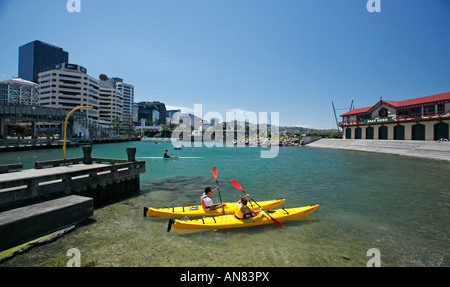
[0, 0, 450, 128]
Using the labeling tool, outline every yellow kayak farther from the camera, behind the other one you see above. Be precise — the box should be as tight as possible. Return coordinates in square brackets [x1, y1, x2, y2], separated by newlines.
[144, 198, 286, 216]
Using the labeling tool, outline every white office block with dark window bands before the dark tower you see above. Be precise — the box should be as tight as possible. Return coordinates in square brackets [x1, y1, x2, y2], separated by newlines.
[38, 63, 100, 123]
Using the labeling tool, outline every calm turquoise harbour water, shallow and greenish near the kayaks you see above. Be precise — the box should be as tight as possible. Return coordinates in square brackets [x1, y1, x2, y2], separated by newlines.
[0, 142, 450, 266]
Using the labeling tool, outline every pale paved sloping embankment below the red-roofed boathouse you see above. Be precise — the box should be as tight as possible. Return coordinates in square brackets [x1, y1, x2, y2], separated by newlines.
[307, 139, 450, 161]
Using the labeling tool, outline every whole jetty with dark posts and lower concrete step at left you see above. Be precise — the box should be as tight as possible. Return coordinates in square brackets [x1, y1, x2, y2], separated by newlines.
[0, 146, 145, 251]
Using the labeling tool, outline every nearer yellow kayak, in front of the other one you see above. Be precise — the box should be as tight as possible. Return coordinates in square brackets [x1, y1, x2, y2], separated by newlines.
[167, 205, 319, 231]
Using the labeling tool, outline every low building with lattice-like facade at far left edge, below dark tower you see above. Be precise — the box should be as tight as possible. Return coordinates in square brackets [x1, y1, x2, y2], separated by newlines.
[0, 78, 39, 106]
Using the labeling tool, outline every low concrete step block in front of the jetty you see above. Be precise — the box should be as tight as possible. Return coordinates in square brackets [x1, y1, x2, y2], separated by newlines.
[0, 195, 94, 251]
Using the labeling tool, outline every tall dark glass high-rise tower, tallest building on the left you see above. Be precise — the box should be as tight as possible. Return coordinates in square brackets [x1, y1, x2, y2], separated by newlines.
[19, 41, 69, 83]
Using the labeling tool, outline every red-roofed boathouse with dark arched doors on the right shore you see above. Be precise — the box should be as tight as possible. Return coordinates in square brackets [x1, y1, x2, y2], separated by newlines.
[339, 92, 450, 141]
